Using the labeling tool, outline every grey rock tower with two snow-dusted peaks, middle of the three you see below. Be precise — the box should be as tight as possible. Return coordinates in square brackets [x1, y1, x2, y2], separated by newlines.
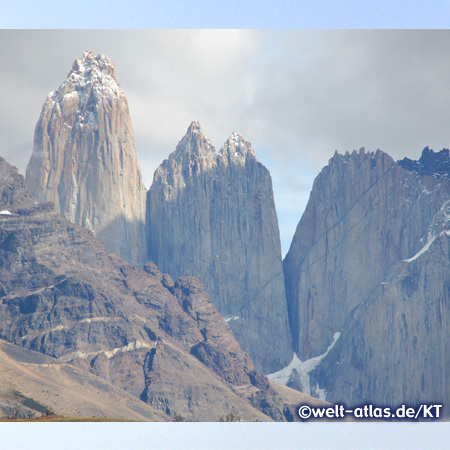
[147, 122, 292, 372]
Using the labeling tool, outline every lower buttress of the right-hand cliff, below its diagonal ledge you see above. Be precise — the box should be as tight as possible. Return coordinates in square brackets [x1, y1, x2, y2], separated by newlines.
[313, 237, 450, 410]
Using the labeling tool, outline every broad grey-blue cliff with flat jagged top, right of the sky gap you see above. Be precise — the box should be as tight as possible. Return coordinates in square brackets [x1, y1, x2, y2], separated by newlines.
[284, 149, 450, 412]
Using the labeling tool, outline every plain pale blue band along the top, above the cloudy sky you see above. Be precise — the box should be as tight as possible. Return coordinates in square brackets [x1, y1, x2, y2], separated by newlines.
[0, 0, 449, 29]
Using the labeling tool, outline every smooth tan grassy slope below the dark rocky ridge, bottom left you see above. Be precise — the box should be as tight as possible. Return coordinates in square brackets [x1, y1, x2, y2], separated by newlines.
[0, 341, 170, 421]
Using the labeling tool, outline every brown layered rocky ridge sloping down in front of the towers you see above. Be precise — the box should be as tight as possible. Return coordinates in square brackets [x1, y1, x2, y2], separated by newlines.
[0, 156, 306, 420]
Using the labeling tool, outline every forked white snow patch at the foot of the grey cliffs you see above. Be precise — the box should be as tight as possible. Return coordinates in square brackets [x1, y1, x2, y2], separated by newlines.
[267, 331, 341, 400]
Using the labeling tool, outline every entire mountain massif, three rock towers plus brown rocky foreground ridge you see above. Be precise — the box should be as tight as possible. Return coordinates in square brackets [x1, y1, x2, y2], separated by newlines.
[0, 52, 450, 420]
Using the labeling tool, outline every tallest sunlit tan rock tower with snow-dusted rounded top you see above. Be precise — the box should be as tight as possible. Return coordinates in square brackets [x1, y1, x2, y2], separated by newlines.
[26, 52, 146, 265]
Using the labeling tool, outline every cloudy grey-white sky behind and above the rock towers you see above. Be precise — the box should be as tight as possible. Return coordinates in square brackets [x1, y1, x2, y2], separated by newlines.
[0, 30, 450, 253]
